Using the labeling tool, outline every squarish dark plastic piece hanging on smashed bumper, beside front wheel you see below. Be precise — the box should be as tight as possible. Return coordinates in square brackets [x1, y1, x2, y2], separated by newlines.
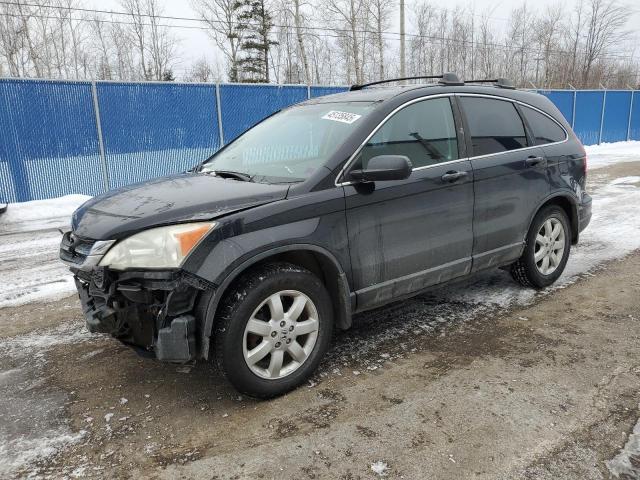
[155, 315, 196, 363]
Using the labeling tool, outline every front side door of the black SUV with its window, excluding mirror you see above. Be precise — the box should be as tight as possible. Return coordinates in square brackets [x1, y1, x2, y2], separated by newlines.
[343, 96, 473, 310]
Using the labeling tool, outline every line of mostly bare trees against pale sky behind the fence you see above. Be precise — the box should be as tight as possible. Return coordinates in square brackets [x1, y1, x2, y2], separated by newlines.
[0, 0, 640, 88]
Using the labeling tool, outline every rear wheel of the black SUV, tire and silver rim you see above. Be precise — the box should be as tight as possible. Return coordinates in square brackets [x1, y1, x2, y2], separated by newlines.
[511, 205, 571, 289]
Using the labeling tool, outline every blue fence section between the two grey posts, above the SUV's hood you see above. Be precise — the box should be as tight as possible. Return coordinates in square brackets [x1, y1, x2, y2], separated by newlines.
[96, 83, 221, 188]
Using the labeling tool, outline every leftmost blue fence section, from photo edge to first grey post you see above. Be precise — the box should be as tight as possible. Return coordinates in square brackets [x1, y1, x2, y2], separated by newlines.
[0, 80, 104, 202]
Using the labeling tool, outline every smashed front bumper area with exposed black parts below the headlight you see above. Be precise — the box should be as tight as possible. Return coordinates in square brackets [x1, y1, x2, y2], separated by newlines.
[74, 267, 209, 363]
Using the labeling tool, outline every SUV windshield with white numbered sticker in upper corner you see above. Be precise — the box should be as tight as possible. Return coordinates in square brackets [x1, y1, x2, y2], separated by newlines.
[201, 102, 373, 183]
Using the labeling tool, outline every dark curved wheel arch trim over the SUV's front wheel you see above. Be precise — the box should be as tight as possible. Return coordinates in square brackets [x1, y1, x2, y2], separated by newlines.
[196, 244, 355, 358]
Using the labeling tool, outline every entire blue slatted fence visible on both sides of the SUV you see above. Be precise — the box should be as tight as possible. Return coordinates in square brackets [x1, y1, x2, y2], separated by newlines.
[0, 79, 640, 202]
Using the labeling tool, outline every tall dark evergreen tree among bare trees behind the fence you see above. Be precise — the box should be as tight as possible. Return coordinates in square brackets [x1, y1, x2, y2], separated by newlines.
[236, 0, 278, 83]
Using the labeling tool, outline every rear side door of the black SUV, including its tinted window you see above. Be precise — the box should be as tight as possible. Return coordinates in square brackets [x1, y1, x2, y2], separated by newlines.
[459, 94, 550, 271]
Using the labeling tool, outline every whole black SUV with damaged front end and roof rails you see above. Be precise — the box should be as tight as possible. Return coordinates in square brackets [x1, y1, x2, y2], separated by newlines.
[60, 74, 591, 398]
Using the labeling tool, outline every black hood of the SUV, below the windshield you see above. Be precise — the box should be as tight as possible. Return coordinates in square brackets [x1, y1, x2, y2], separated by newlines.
[72, 173, 289, 240]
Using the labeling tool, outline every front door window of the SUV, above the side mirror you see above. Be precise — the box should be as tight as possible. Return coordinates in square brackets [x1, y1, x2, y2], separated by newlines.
[356, 98, 458, 168]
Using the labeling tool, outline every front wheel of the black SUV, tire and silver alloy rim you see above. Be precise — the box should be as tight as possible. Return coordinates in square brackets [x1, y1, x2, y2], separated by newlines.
[214, 263, 333, 399]
